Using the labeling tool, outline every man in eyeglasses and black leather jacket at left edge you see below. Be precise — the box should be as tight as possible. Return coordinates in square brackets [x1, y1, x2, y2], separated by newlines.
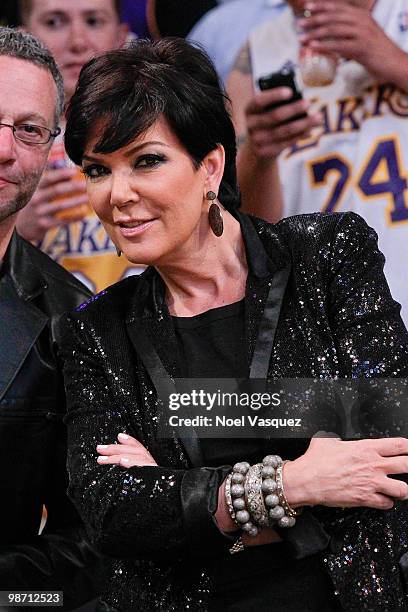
[0, 28, 98, 610]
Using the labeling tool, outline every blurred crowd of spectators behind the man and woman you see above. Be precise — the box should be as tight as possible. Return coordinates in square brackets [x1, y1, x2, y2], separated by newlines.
[0, 0, 408, 322]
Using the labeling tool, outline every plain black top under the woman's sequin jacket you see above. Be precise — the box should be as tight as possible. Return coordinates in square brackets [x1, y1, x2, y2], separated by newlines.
[172, 300, 342, 612]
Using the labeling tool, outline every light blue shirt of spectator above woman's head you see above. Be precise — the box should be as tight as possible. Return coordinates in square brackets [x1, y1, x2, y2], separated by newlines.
[188, 0, 286, 82]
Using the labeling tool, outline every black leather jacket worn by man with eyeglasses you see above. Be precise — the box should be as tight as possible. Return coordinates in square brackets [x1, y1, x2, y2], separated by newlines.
[0, 233, 102, 610]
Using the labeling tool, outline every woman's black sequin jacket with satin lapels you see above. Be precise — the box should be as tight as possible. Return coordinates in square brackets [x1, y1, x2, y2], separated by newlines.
[59, 213, 408, 612]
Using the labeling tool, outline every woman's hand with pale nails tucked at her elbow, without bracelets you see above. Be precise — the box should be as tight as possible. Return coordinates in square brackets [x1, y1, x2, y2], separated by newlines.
[96, 433, 157, 469]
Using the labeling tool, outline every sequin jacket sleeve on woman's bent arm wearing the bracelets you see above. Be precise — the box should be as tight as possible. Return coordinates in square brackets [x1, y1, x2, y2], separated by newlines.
[58, 315, 230, 561]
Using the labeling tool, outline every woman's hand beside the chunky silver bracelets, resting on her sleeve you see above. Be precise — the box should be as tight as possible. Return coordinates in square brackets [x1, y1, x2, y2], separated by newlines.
[283, 438, 408, 510]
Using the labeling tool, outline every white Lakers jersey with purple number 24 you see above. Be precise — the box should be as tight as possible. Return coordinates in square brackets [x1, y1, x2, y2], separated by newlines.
[249, 0, 408, 324]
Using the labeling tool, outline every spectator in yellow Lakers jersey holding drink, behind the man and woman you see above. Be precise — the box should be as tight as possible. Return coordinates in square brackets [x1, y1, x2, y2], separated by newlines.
[17, 0, 137, 291]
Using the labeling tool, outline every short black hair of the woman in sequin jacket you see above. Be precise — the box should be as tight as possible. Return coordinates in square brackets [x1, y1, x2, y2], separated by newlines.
[65, 38, 239, 209]
